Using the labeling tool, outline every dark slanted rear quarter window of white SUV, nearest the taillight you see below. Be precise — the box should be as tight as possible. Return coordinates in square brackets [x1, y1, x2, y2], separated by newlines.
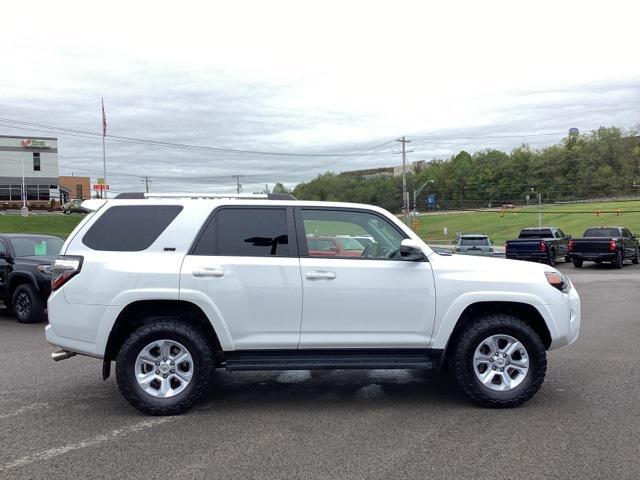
[82, 205, 182, 252]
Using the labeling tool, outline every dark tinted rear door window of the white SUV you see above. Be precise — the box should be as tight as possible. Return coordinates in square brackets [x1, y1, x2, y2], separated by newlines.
[216, 208, 289, 257]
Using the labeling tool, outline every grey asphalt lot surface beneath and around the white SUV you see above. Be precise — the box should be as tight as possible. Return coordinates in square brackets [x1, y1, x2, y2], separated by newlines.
[0, 265, 640, 479]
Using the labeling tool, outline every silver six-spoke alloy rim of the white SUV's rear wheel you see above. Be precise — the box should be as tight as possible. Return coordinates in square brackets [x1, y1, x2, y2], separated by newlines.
[134, 339, 193, 398]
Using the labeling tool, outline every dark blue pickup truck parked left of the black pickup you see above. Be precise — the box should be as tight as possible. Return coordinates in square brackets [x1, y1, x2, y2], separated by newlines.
[504, 227, 571, 266]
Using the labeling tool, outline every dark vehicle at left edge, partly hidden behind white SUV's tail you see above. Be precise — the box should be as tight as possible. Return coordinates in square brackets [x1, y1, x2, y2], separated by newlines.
[0, 233, 64, 323]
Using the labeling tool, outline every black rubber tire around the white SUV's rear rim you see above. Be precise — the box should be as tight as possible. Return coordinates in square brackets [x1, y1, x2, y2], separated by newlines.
[116, 317, 215, 415]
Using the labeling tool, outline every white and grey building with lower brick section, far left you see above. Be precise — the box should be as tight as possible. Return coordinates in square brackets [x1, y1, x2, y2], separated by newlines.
[0, 135, 91, 206]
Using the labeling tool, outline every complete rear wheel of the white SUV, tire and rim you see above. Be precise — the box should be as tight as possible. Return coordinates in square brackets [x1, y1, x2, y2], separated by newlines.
[116, 317, 215, 415]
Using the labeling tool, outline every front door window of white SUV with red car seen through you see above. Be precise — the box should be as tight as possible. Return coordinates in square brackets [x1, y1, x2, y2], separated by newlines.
[302, 209, 404, 260]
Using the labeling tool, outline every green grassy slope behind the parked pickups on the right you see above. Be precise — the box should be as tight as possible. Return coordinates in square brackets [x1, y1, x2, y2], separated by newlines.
[417, 200, 640, 245]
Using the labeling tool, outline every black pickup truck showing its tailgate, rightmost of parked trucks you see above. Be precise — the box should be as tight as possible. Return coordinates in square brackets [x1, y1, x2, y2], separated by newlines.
[569, 227, 638, 268]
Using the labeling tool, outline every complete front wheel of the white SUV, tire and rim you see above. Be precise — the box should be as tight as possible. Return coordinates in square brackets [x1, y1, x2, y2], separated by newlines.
[452, 314, 547, 408]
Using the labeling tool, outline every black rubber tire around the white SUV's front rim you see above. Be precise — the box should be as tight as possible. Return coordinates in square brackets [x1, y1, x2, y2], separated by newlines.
[451, 314, 547, 408]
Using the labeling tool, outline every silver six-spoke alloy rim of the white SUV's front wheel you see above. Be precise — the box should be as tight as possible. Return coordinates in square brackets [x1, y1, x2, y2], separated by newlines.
[473, 334, 530, 392]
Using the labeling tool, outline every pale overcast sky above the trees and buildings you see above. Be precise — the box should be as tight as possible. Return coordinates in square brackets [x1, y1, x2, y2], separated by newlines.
[0, 0, 640, 192]
